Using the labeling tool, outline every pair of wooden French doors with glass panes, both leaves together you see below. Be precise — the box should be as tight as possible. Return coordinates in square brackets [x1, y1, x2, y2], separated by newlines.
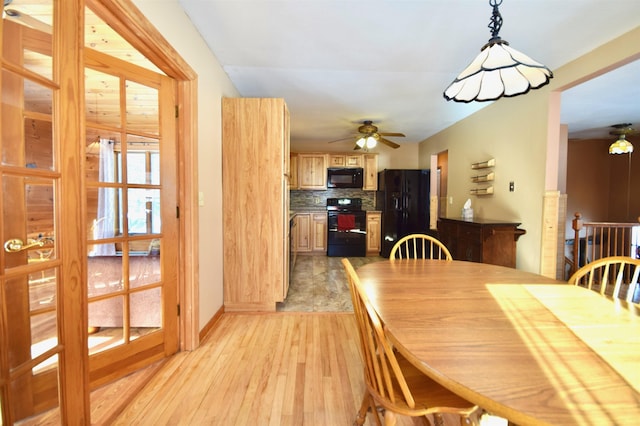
[0, 0, 179, 424]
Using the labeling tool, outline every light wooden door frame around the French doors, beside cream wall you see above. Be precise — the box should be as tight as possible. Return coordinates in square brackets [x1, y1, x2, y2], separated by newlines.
[86, 0, 199, 350]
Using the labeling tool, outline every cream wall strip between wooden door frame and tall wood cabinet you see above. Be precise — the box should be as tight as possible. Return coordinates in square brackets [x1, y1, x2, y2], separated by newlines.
[134, 0, 238, 327]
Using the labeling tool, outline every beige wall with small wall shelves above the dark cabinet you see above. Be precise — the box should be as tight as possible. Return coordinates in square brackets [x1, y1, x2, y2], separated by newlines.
[420, 27, 640, 272]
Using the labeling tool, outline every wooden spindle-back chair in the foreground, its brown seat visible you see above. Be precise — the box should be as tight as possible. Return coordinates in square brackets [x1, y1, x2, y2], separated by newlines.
[342, 258, 482, 426]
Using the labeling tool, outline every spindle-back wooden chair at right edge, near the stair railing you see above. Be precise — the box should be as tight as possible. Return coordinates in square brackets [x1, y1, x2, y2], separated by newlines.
[569, 256, 640, 304]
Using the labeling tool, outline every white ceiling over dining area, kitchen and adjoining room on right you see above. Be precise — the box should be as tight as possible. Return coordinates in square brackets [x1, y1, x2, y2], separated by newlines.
[179, 0, 640, 149]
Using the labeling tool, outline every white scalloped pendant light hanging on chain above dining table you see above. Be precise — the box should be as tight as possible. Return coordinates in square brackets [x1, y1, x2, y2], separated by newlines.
[444, 0, 553, 103]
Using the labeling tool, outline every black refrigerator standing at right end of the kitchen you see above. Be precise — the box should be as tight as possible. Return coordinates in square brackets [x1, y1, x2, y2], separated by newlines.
[376, 169, 430, 257]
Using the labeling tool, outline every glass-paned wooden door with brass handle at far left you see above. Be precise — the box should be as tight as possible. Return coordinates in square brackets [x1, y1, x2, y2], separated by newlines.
[0, 1, 63, 424]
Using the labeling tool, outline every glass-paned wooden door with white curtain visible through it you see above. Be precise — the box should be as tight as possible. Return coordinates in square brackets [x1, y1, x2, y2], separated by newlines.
[85, 17, 178, 386]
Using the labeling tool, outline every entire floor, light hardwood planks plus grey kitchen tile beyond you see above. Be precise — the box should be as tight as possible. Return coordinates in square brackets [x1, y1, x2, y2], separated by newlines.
[23, 256, 468, 426]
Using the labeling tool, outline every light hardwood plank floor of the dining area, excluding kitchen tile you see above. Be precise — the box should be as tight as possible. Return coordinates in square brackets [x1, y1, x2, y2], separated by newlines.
[113, 312, 452, 426]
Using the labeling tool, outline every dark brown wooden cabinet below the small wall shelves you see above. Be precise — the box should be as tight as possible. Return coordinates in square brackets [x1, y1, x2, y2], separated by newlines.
[438, 218, 526, 268]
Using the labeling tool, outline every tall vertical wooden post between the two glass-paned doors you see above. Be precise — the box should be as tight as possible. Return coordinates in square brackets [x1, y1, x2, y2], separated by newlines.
[53, 1, 91, 425]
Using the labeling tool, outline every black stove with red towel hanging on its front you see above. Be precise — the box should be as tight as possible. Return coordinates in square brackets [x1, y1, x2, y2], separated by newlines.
[327, 198, 367, 257]
